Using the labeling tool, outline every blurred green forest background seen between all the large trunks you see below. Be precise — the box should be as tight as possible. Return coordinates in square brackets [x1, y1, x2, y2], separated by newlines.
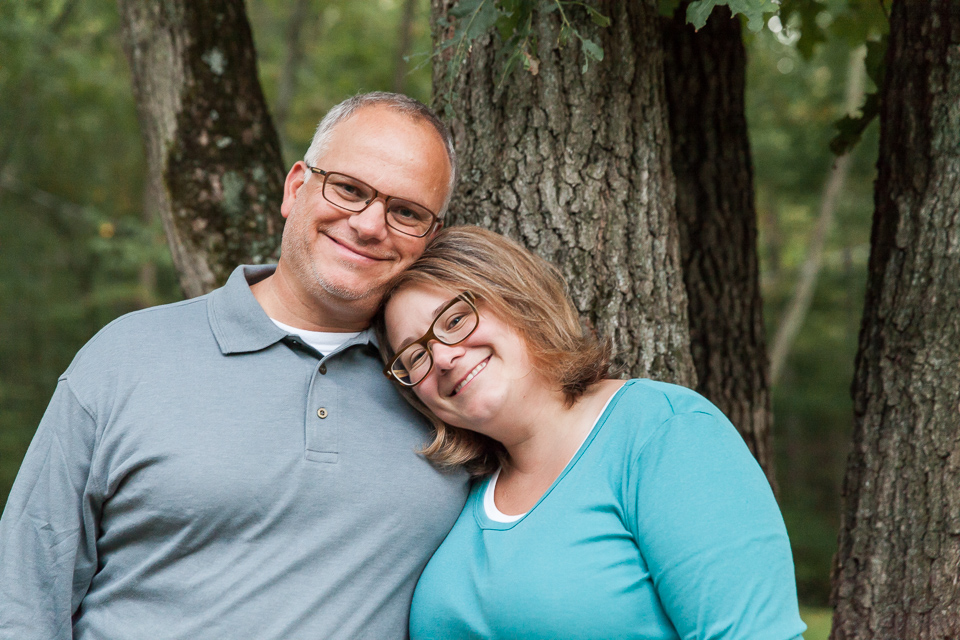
[0, 0, 883, 632]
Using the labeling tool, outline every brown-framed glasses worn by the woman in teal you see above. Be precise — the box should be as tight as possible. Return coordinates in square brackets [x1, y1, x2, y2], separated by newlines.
[383, 291, 480, 387]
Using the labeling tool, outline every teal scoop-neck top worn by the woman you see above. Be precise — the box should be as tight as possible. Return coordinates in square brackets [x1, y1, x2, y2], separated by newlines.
[410, 380, 805, 640]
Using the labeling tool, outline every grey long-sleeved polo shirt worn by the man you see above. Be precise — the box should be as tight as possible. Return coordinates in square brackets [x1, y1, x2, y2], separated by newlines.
[0, 267, 467, 640]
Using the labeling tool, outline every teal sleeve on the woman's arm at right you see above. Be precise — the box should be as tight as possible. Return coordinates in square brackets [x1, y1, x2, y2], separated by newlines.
[630, 412, 805, 640]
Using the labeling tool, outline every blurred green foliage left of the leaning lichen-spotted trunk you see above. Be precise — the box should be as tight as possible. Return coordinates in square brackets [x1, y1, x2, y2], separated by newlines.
[0, 0, 177, 500]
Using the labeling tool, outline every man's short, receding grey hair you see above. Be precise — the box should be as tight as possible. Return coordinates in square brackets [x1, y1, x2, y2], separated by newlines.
[303, 91, 458, 218]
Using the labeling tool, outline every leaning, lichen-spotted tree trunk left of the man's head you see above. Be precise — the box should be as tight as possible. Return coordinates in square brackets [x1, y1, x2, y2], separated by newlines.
[119, 0, 284, 297]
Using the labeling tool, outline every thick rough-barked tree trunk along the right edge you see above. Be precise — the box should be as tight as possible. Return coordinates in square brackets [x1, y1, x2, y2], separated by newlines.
[830, 0, 960, 640]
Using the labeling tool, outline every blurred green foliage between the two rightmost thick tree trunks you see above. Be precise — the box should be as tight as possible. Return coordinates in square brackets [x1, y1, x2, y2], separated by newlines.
[747, 1, 885, 606]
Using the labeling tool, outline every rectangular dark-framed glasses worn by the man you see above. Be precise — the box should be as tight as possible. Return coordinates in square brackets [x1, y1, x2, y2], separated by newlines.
[307, 165, 437, 238]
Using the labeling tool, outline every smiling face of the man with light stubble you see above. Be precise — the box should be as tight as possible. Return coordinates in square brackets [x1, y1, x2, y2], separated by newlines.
[280, 106, 450, 306]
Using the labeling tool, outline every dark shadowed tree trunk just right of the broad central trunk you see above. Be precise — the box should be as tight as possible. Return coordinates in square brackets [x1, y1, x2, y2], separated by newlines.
[663, 3, 776, 487]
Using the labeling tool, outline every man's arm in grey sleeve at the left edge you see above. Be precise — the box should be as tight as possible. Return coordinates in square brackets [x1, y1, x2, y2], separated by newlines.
[0, 376, 99, 640]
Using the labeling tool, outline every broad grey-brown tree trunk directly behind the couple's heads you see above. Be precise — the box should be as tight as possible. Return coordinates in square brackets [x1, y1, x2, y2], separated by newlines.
[432, 0, 696, 386]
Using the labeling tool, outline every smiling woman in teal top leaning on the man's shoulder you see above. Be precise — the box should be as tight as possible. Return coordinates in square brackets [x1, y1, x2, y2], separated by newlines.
[378, 227, 804, 640]
